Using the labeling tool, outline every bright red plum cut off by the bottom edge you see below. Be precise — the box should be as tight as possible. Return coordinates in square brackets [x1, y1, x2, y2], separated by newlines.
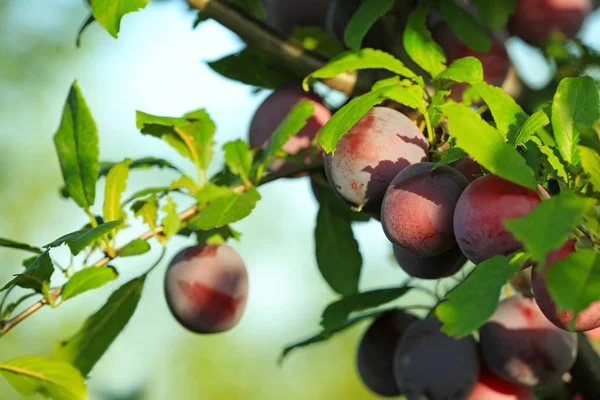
[467, 366, 534, 400]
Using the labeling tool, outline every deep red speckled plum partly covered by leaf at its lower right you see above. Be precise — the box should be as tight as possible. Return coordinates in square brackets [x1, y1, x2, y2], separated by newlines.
[454, 175, 547, 264]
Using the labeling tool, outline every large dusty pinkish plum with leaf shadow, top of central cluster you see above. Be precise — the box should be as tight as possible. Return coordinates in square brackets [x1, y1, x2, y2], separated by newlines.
[325, 107, 428, 212]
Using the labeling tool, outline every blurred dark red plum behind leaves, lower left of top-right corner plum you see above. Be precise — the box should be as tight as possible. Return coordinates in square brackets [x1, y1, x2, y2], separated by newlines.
[431, 22, 510, 101]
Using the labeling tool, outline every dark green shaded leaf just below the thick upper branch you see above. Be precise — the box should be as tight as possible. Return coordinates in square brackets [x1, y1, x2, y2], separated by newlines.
[207, 47, 296, 89]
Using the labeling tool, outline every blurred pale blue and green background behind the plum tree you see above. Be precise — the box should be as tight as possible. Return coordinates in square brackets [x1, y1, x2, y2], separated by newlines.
[0, 0, 600, 400]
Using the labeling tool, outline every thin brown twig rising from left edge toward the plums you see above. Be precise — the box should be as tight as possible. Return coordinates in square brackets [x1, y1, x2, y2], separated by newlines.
[0, 161, 323, 337]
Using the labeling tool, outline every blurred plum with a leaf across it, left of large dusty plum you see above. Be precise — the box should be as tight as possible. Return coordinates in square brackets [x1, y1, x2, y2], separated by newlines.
[248, 86, 331, 171]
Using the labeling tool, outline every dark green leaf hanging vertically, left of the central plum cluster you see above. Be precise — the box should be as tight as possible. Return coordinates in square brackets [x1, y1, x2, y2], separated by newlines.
[315, 202, 362, 295]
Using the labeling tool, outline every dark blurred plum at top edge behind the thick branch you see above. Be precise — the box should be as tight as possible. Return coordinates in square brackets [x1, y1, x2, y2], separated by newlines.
[263, 0, 331, 35]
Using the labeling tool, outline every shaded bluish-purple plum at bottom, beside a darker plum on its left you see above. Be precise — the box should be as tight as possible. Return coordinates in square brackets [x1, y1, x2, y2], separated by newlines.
[394, 319, 479, 400]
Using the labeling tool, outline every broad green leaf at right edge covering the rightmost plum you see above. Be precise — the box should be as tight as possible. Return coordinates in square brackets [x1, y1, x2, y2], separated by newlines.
[546, 249, 600, 329]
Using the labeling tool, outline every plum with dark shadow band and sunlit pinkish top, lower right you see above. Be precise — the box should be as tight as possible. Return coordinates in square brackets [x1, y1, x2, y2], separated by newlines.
[479, 295, 577, 387]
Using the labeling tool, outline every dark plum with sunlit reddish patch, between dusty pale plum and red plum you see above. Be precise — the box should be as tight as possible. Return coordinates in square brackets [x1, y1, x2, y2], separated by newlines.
[381, 162, 469, 257]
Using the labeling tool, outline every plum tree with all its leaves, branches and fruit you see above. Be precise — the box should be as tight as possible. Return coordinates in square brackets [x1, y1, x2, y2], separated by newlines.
[0, 0, 600, 400]
